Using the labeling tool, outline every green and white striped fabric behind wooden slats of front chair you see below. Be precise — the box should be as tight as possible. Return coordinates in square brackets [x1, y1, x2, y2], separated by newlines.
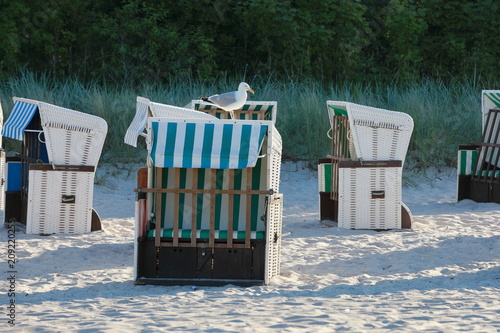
[148, 159, 267, 239]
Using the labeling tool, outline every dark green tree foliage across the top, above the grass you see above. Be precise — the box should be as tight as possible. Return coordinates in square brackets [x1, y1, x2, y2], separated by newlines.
[0, 0, 500, 83]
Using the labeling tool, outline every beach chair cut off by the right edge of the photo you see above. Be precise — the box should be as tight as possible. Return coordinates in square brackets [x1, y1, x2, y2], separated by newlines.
[457, 90, 500, 203]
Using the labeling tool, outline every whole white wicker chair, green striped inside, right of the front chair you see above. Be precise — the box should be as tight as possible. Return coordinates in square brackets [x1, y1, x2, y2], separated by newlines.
[318, 101, 413, 230]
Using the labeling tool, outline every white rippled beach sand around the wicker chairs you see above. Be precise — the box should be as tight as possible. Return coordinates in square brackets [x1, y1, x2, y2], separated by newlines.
[0, 163, 500, 332]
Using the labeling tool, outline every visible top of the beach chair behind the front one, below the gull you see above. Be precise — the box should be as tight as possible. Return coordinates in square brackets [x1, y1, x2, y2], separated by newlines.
[191, 100, 278, 124]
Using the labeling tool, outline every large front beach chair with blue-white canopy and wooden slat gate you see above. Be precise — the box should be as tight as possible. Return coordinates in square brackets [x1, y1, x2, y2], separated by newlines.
[127, 99, 282, 286]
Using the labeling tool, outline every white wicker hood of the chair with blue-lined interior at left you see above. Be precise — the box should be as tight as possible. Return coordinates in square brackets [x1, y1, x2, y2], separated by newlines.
[38, 102, 108, 166]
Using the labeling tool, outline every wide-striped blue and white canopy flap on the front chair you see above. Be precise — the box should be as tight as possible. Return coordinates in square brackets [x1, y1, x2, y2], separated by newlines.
[149, 118, 269, 169]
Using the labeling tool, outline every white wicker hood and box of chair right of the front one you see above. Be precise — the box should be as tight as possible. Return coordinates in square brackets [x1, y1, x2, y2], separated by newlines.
[327, 101, 413, 229]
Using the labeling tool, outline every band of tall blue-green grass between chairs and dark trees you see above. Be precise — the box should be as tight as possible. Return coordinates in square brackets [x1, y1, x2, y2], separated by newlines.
[0, 73, 495, 168]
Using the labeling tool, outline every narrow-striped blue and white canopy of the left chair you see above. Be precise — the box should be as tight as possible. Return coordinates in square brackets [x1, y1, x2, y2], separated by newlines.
[2, 100, 38, 141]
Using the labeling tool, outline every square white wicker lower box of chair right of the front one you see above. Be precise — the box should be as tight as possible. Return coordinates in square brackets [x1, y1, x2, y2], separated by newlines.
[338, 167, 402, 229]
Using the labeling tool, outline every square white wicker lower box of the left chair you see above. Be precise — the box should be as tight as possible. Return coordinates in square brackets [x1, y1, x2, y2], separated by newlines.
[26, 166, 94, 234]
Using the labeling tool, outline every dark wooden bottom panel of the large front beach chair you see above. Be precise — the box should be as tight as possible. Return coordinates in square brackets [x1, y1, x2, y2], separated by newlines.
[136, 237, 266, 285]
